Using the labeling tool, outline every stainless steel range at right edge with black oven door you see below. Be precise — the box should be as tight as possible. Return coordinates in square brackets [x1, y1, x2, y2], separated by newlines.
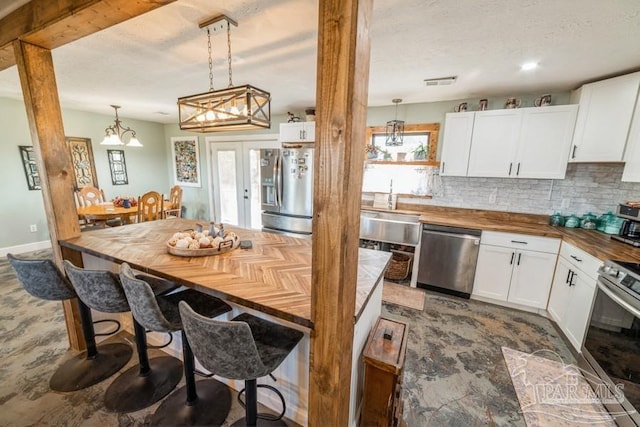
[582, 261, 640, 426]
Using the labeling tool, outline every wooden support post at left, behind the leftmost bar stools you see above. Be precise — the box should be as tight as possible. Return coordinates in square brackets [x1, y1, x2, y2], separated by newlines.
[13, 40, 84, 350]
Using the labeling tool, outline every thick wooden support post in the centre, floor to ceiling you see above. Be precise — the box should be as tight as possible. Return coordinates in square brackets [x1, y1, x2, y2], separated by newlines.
[309, 0, 373, 427]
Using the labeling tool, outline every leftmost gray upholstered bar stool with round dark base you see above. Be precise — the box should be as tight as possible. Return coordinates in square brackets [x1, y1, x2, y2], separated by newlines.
[7, 254, 133, 392]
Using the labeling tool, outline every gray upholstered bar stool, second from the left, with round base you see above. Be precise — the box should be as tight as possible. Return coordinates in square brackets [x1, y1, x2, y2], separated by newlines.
[64, 261, 182, 412]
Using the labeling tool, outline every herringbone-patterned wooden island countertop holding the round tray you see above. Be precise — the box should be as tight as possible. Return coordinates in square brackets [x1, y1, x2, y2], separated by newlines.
[60, 219, 391, 329]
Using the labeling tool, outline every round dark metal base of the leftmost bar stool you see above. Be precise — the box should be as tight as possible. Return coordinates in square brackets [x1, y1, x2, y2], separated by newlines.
[49, 343, 133, 392]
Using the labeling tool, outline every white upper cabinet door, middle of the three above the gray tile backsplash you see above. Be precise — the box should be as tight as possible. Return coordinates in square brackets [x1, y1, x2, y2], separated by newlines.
[468, 109, 522, 177]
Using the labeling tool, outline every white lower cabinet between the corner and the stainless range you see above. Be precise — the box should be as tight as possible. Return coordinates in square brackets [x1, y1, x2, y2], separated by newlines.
[547, 242, 602, 352]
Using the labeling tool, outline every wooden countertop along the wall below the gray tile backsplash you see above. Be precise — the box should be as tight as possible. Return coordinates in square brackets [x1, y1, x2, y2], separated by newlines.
[362, 204, 640, 263]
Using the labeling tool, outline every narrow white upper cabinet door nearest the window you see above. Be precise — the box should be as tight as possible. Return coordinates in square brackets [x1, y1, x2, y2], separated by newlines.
[440, 112, 475, 176]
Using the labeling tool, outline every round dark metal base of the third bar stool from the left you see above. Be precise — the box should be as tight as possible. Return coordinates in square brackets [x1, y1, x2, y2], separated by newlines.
[150, 379, 231, 426]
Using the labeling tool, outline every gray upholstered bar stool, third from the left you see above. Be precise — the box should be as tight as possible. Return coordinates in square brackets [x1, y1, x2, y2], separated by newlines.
[120, 263, 231, 426]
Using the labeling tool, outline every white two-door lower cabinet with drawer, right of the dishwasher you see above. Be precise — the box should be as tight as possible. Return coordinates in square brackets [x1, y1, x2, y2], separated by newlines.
[472, 231, 560, 309]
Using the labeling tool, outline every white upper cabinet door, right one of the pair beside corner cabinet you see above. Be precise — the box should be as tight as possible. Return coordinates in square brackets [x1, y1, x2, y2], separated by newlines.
[511, 105, 578, 179]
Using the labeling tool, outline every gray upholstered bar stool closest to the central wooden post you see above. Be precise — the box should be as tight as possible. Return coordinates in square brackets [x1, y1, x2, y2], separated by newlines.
[179, 302, 304, 426]
